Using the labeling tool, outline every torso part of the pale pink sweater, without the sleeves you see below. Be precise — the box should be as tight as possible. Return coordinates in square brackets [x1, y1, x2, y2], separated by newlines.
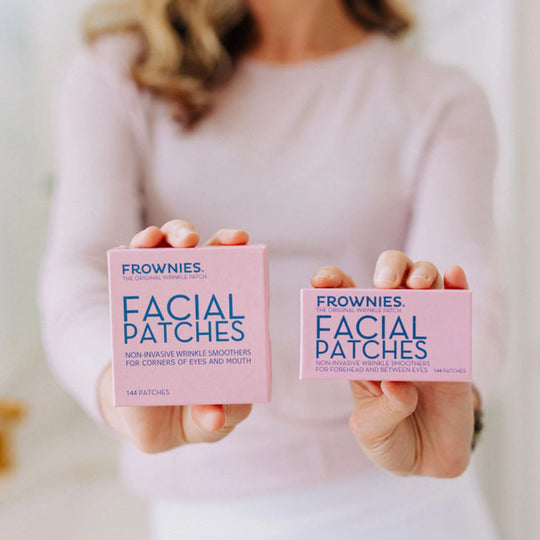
[86, 31, 478, 496]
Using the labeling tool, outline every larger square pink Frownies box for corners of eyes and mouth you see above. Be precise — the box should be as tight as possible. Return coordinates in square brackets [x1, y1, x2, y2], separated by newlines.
[107, 246, 271, 406]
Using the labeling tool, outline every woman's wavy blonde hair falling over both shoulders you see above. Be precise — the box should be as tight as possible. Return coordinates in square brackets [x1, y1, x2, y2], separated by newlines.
[84, 0, 411, 127]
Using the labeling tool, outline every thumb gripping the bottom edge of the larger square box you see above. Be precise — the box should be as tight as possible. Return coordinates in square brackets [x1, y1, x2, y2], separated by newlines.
[183, 404, 251, 443]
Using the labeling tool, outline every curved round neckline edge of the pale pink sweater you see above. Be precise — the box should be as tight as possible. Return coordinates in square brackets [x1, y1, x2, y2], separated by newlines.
[239, 32, 387, 73]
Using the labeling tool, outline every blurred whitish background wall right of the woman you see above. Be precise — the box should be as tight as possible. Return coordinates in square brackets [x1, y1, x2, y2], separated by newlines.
[417, 0, 540, 540]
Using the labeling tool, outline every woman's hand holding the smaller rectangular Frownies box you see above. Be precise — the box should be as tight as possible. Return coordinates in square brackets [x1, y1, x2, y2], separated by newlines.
[311, 251, 473, 478]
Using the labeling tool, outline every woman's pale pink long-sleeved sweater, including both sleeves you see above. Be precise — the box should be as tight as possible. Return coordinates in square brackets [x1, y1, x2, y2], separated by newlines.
[40, 35, 502, 496]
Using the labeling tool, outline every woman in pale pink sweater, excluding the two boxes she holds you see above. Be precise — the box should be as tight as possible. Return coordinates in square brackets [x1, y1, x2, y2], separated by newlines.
[41, 0, 500, 538]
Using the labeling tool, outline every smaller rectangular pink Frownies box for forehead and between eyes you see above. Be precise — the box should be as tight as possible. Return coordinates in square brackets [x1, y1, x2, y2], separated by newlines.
[300, 289, 472, 381]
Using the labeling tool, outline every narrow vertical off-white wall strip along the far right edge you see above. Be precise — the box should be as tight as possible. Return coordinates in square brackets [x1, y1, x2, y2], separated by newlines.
[510, 0, 540, 538]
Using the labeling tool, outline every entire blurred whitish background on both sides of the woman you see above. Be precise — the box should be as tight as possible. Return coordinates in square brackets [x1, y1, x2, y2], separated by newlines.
[0, 0, 540, 540]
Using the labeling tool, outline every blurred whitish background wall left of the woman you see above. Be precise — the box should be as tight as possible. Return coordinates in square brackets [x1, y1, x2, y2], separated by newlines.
[0, 0, 147, 540]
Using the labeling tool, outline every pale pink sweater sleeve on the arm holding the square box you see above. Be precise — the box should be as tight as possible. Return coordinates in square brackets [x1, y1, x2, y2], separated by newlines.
[39, 42, 146, 429]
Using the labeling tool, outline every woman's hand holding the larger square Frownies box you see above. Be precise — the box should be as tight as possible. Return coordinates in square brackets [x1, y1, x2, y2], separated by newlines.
[98, 219, 251, 453]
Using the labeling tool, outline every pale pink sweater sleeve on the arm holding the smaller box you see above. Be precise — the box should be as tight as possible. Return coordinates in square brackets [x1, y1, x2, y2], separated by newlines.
[406, 74, 504, 399]
